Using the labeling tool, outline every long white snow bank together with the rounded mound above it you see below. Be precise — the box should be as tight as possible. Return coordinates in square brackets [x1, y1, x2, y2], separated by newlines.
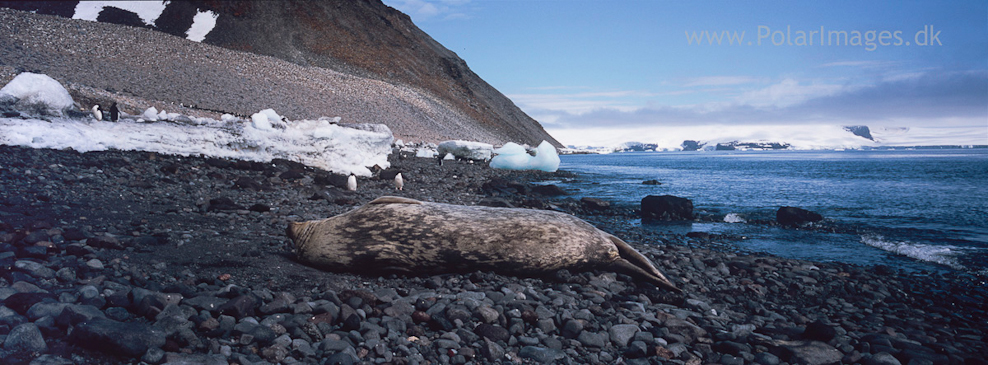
[0, 73, 394, 176]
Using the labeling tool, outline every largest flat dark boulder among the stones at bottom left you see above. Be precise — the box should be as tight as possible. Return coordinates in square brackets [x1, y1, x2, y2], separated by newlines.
[70, 318, 165, 357]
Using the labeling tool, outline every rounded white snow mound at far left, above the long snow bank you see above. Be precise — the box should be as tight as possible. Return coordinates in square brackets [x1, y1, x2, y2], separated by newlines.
[0, 72, 75, 116]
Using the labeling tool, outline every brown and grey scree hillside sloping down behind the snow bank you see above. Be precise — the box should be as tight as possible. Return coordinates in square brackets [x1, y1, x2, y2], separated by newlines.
[0, 0, 559, 146]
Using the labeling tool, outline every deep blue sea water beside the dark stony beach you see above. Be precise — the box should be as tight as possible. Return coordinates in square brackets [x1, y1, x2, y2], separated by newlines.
[554, 149, 988, 276]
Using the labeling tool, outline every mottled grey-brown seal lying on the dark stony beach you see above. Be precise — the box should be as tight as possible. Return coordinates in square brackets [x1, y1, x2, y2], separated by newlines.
[287, 196, 679, 291]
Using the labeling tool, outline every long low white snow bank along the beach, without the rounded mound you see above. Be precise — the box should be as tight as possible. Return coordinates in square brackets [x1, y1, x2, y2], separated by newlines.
[0, 113, 394, 176]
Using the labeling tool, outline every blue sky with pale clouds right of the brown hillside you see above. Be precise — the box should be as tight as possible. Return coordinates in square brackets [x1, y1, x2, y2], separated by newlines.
[385, 0, 988, 145]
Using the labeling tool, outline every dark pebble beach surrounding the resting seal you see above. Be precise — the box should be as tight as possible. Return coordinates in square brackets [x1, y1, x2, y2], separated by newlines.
[0, 146, 988, 364]
